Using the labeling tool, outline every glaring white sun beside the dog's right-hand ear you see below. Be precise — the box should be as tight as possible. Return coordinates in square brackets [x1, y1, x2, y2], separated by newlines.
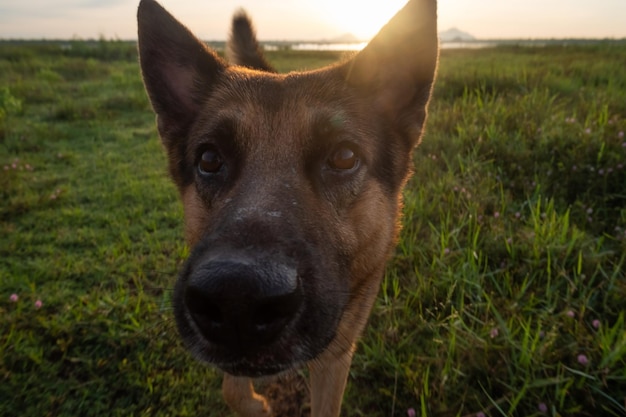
[322, 0, 407, 40]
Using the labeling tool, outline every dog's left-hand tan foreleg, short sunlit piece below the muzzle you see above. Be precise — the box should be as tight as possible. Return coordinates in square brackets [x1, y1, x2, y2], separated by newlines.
[222, 374, 272, 417]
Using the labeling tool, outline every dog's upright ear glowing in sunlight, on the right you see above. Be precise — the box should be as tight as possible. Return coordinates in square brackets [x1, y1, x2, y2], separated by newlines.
[344, 0, 439, 146]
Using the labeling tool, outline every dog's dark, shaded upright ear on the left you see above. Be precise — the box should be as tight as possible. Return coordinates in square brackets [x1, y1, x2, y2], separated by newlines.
[137, 0, 227, 141]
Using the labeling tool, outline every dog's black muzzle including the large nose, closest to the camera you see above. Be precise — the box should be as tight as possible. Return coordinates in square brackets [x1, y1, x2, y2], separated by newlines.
[173, 219, 349, 376]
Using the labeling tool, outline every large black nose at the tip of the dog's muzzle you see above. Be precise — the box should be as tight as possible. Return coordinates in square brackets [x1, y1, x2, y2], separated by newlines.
[184, 258, 302, 353]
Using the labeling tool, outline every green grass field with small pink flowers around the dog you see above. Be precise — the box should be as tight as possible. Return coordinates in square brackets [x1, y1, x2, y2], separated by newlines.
[0, 41, 626, 417]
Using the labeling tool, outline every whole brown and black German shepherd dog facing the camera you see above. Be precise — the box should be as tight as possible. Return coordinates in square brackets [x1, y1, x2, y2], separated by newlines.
[138, 0, 438, 417]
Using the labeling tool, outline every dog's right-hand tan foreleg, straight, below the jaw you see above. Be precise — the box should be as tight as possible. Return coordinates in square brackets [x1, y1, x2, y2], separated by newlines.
[309, 342, 354, 417]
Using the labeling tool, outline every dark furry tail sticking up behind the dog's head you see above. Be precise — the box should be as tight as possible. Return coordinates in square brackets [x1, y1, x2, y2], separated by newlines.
[226, 10, 276, 72]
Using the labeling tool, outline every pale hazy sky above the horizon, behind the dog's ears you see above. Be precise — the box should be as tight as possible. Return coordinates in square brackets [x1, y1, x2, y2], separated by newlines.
[0, 0, 626, 40]
